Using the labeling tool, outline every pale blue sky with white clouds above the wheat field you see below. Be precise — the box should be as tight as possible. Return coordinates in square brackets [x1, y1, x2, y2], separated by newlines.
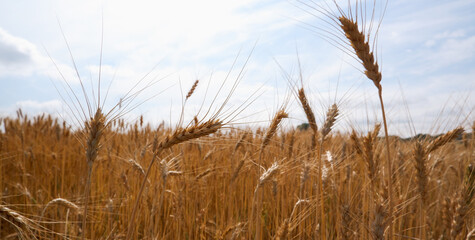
[0, 0, 475, 136]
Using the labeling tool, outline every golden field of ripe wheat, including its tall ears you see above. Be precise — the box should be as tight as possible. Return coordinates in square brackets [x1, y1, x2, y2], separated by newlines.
[0, 0, 475, 240]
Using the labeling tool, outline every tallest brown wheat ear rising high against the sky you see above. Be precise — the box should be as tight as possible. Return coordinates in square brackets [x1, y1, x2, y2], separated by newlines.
[338, 16, 382, 89]
